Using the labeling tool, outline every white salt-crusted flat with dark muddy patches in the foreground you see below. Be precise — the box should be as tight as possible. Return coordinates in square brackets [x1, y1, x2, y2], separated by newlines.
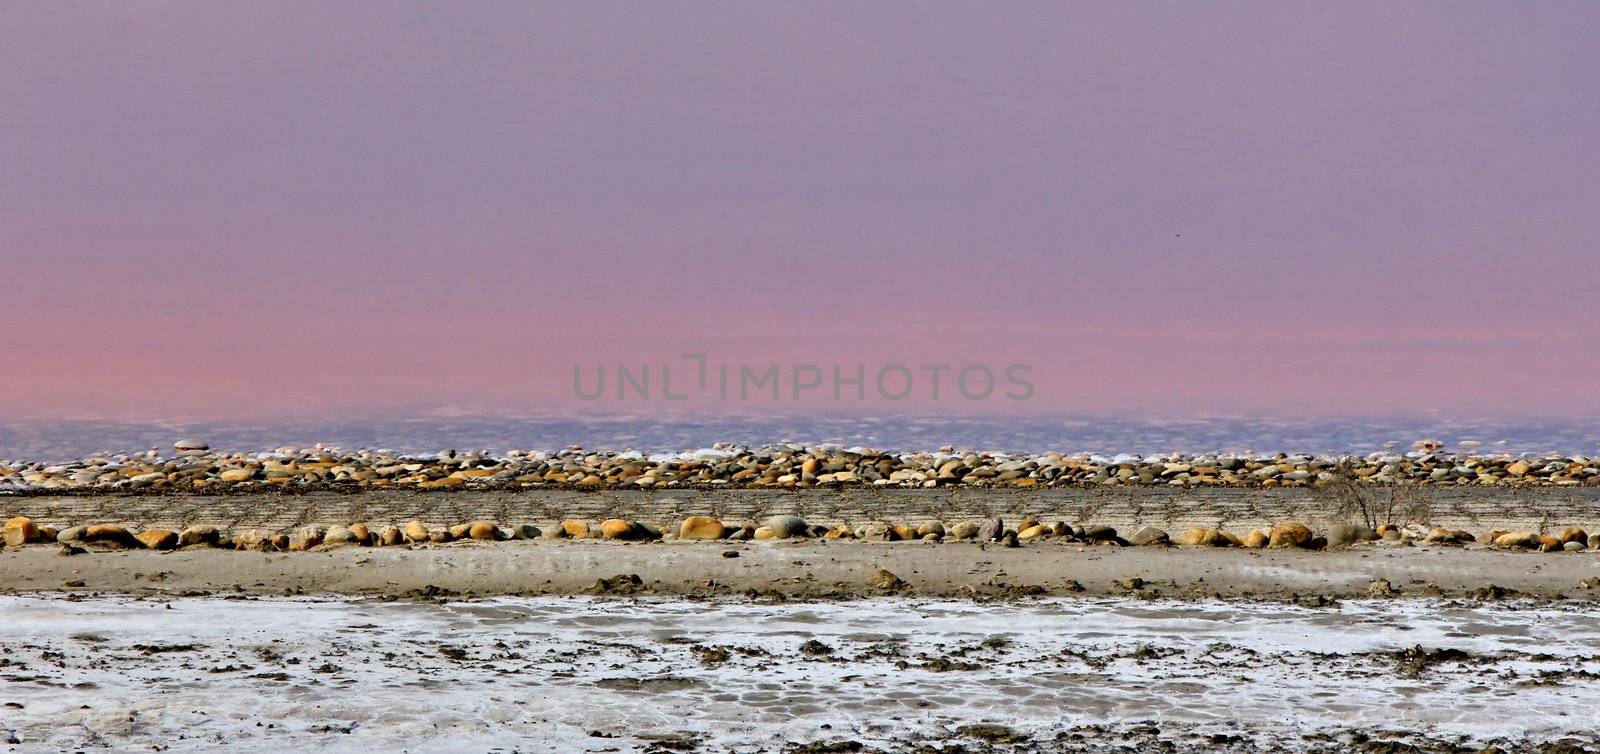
[0, 596, 1600, 752]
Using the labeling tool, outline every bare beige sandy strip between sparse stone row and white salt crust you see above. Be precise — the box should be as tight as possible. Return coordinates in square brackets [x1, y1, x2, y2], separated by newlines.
[0, 541, 1600, 599]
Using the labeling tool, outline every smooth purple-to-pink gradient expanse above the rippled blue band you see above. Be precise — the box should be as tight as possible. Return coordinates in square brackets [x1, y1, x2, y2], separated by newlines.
[0, 0, 1600, 416]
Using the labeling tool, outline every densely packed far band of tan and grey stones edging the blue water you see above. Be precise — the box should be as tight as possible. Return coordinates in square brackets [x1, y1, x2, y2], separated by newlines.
[0, 440, 1600, 495]
